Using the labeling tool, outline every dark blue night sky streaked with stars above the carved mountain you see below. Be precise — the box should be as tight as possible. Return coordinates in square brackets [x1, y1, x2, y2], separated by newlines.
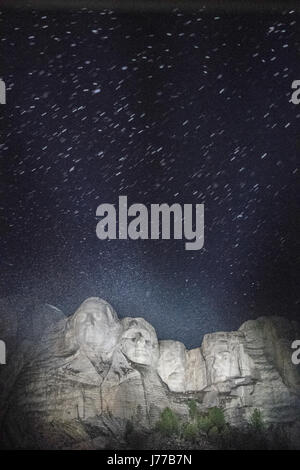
[0, 5, 300, 347]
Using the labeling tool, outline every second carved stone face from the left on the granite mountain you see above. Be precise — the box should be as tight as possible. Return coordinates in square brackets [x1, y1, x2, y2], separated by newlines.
[120, 318, 159, 366]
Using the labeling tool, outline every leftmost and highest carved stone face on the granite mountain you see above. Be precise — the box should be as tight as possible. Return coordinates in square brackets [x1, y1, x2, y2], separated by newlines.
[67, 297, 121, 356]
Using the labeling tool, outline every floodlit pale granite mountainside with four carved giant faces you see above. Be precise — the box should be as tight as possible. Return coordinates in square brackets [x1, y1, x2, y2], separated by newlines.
[0, 298, 300, 448]
